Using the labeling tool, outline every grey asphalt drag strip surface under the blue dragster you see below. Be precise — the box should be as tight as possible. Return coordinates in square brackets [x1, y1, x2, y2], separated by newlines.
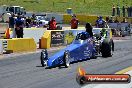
[0, 40, 132, 88]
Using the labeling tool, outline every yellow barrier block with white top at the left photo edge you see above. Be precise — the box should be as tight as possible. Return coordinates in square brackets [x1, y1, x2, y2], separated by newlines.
[0, 38, 36, 52]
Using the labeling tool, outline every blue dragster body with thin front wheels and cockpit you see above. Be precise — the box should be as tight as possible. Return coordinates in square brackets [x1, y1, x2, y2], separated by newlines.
[40, 32, 96, 67]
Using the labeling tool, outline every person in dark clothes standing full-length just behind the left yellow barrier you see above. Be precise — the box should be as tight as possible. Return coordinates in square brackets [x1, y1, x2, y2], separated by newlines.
[15, 13, 24, 38]
